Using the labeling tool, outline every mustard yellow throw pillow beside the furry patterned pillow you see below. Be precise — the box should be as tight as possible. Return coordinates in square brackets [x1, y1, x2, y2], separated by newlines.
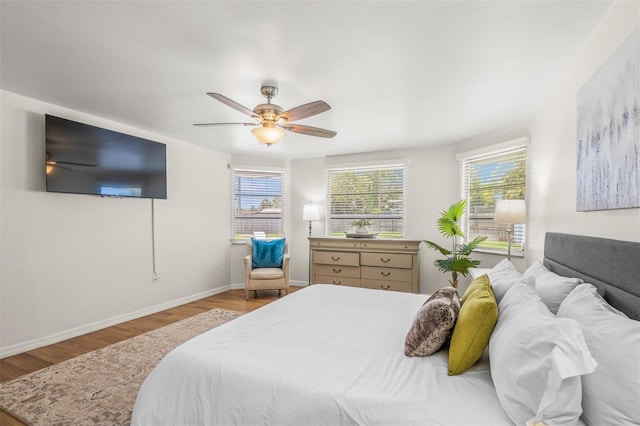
[449, 276, 498, 376]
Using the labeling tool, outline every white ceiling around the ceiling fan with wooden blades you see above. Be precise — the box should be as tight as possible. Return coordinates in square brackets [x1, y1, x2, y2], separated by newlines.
[0, 0, 611, 158]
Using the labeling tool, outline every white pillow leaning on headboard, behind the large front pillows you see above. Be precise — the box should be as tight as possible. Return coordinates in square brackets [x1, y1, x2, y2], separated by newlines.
[523, 262, 583, 314]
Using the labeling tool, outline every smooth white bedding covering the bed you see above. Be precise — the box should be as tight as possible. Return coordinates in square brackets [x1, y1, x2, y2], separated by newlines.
[131, 284, 512, 426]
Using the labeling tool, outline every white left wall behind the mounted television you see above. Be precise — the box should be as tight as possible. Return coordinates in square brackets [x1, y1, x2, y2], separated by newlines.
[0, 91, 231, 356]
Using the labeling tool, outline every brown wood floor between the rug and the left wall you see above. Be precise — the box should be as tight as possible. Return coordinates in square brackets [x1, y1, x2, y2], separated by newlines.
[0, 287, 300, 426]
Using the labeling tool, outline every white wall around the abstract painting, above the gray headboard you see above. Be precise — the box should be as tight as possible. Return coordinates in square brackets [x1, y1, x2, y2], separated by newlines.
[528, 1, 640, 260]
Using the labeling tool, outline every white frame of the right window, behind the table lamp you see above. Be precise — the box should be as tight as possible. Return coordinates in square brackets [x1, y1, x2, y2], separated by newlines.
[456, 137, 529, 257]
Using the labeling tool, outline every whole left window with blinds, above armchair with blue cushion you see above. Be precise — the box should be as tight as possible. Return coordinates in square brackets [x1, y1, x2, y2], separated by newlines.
[231, 169, 285, 239]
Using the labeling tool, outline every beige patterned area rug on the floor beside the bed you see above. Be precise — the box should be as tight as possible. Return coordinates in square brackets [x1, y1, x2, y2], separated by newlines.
[0, 309, 241, 426]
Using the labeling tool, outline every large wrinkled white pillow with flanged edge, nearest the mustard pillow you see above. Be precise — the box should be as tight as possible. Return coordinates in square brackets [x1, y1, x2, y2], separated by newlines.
[489, 283, 597, 425]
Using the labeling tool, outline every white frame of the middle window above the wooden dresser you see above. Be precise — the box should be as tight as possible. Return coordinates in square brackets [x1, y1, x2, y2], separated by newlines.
[324, 160, 407, 239]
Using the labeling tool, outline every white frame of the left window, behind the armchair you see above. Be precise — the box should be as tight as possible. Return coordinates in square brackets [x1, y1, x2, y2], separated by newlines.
[229, 165, 287, 242]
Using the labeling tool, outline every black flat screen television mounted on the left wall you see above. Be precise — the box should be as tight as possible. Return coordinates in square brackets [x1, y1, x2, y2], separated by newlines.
[45, 114, 167, 199]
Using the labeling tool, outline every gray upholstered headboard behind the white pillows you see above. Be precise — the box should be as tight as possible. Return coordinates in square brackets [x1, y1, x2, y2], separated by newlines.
[543, 232, 640, 320]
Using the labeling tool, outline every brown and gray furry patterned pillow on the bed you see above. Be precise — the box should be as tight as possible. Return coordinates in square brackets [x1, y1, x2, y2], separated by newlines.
[404, 287, 460, 356]
